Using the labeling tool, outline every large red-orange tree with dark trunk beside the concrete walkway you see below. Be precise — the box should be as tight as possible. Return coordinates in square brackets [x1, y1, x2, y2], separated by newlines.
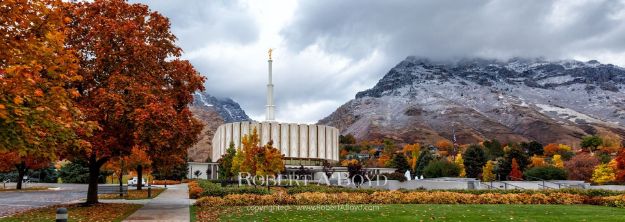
[66, 0, 204, 204]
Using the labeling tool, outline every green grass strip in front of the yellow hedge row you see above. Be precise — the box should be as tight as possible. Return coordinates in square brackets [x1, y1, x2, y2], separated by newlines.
[219, 204, 625, 222]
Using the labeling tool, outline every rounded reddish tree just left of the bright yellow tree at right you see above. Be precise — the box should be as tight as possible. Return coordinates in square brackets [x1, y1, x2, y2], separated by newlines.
[564, 153, 599, 181]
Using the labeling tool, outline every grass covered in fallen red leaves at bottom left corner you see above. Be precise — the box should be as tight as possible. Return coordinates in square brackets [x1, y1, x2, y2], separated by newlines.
[0, 203, 142, 222]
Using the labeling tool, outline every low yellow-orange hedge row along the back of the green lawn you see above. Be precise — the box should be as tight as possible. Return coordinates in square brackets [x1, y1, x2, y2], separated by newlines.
[195, 191, 625, 207]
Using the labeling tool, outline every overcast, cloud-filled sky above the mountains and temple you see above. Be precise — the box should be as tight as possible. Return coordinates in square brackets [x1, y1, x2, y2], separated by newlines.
[131, 0, 625, 123]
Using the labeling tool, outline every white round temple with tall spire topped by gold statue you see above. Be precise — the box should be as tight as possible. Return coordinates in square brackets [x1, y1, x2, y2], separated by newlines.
[211, 49, 339, 166]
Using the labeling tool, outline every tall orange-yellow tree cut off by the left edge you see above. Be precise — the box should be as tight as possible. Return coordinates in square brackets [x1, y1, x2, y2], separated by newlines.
[0, 0, 95, 189]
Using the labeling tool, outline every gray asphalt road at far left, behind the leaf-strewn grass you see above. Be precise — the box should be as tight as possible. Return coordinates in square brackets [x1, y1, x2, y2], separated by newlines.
[0, 183, 87, 217]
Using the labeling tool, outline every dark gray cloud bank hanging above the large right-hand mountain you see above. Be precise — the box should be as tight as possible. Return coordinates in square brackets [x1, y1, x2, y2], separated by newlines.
[282, 0, 625, 58]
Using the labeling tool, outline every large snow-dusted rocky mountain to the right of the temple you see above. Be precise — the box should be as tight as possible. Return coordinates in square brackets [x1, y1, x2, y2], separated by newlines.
[319, 57, 625, 146]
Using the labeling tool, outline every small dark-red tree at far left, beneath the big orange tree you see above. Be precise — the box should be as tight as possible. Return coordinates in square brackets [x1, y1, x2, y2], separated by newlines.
[0, 152, 50, 190]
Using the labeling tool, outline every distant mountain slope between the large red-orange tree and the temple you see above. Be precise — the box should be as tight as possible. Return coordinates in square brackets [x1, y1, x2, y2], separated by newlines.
[188, 92, 250, 162]
